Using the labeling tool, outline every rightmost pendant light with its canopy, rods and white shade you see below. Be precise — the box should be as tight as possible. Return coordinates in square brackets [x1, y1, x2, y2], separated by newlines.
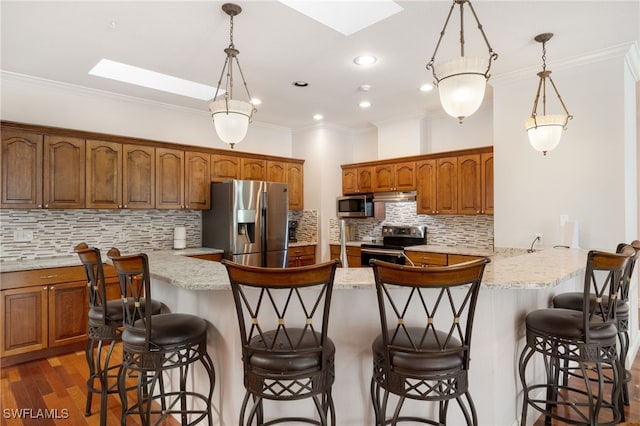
[524, 33, 573, 155]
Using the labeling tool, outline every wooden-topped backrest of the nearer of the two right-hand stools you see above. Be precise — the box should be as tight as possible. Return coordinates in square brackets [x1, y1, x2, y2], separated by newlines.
[582, 245, 636, 343]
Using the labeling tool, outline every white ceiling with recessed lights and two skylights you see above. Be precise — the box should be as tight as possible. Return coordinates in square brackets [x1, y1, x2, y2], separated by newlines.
[0, 0, 640, 129]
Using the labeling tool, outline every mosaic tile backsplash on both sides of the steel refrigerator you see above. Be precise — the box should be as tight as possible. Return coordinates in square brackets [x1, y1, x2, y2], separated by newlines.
[0, 209, 318, 261]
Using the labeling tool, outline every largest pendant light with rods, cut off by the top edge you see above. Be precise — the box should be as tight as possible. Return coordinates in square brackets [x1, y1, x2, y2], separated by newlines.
[427, 0, 498, 123]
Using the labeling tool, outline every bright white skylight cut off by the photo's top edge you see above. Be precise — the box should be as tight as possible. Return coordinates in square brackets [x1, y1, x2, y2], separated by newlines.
[280, 0, 403, 36]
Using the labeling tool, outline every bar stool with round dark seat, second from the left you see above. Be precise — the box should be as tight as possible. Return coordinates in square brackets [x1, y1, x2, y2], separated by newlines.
[107, 250, 215, 426]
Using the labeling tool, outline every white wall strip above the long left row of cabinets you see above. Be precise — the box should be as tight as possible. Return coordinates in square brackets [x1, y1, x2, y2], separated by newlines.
[0, 72, 292, 157]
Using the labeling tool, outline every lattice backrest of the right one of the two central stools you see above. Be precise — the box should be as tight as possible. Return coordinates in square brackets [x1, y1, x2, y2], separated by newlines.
[371, 258, 489, 371]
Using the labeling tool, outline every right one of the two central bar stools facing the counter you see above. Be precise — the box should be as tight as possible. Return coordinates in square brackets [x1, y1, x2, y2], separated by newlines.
[371, 258, 489, 426]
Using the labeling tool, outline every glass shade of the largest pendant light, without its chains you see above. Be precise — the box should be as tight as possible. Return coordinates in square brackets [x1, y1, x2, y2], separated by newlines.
[436, 57, 489, 122]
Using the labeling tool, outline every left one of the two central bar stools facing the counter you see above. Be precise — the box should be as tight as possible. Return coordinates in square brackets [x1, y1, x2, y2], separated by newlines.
[222, 260, 338, 426]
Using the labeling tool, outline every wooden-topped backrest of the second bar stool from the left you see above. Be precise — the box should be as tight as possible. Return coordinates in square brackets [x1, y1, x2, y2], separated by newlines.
[107, 249, 152, 351]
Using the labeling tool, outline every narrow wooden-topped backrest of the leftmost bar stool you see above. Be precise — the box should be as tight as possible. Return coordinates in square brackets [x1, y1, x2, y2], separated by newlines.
[74, 243, 107, 324]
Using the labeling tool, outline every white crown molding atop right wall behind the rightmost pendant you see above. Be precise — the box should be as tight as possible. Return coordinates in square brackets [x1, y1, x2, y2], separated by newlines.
[491, 41, 638, 86]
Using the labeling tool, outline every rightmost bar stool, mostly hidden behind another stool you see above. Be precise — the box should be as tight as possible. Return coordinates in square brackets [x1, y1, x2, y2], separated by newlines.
[553, 240, 640, 406]
